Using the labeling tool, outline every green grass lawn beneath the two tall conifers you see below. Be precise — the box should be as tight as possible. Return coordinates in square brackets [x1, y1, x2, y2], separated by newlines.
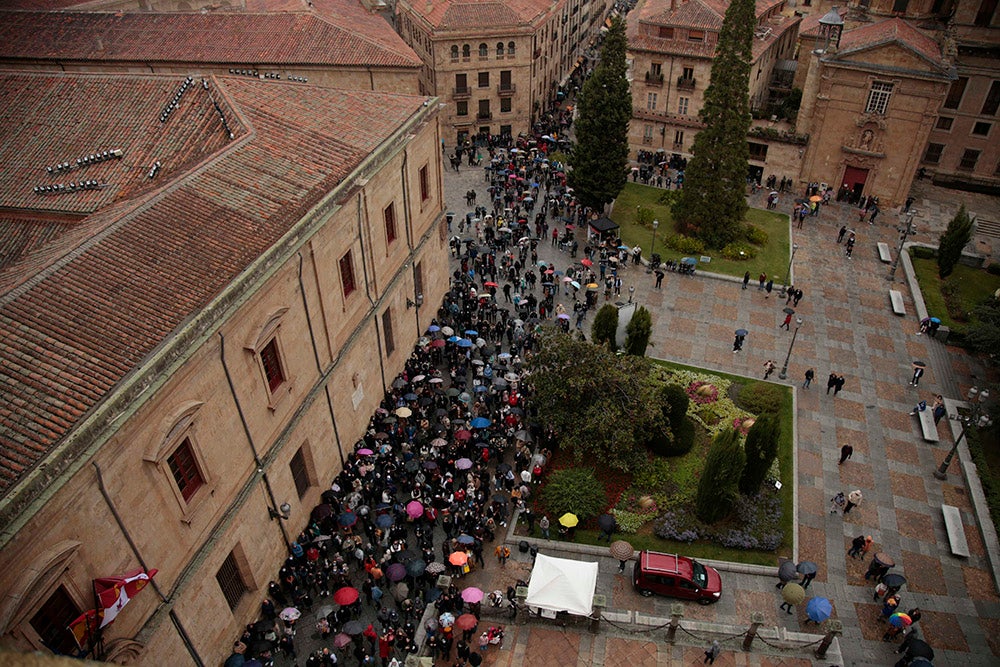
[611, 183, 791, 283]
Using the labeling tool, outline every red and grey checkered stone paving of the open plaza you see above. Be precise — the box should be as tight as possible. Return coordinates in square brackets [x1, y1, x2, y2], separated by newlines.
[445, 158, 1000, 665]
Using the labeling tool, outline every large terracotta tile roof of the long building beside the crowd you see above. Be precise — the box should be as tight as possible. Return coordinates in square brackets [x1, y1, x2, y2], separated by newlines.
[0, 73, 426, 494]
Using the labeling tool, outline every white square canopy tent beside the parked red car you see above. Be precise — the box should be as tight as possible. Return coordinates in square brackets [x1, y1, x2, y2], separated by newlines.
[525, 554, 597, 616]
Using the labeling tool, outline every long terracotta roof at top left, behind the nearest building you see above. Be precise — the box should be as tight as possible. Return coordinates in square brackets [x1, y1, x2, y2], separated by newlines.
[0, 9, 420, 67]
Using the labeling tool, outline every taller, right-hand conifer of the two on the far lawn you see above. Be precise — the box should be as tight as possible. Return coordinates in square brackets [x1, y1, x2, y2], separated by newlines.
[673, 0, 756, 248]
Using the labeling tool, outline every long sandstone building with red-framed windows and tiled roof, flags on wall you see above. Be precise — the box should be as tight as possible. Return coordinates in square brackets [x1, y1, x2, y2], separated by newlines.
[0, 73, 448, 665]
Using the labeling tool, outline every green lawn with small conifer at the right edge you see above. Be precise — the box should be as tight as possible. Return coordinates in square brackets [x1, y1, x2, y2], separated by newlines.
[910, 252, 1000, 334]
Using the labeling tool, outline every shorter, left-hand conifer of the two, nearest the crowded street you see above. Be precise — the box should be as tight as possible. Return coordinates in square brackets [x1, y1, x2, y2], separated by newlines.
[569, 17, 632, 211]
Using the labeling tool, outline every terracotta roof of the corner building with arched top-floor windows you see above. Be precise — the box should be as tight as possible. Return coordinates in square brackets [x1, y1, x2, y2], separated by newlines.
[406, 0, 556, 30]
